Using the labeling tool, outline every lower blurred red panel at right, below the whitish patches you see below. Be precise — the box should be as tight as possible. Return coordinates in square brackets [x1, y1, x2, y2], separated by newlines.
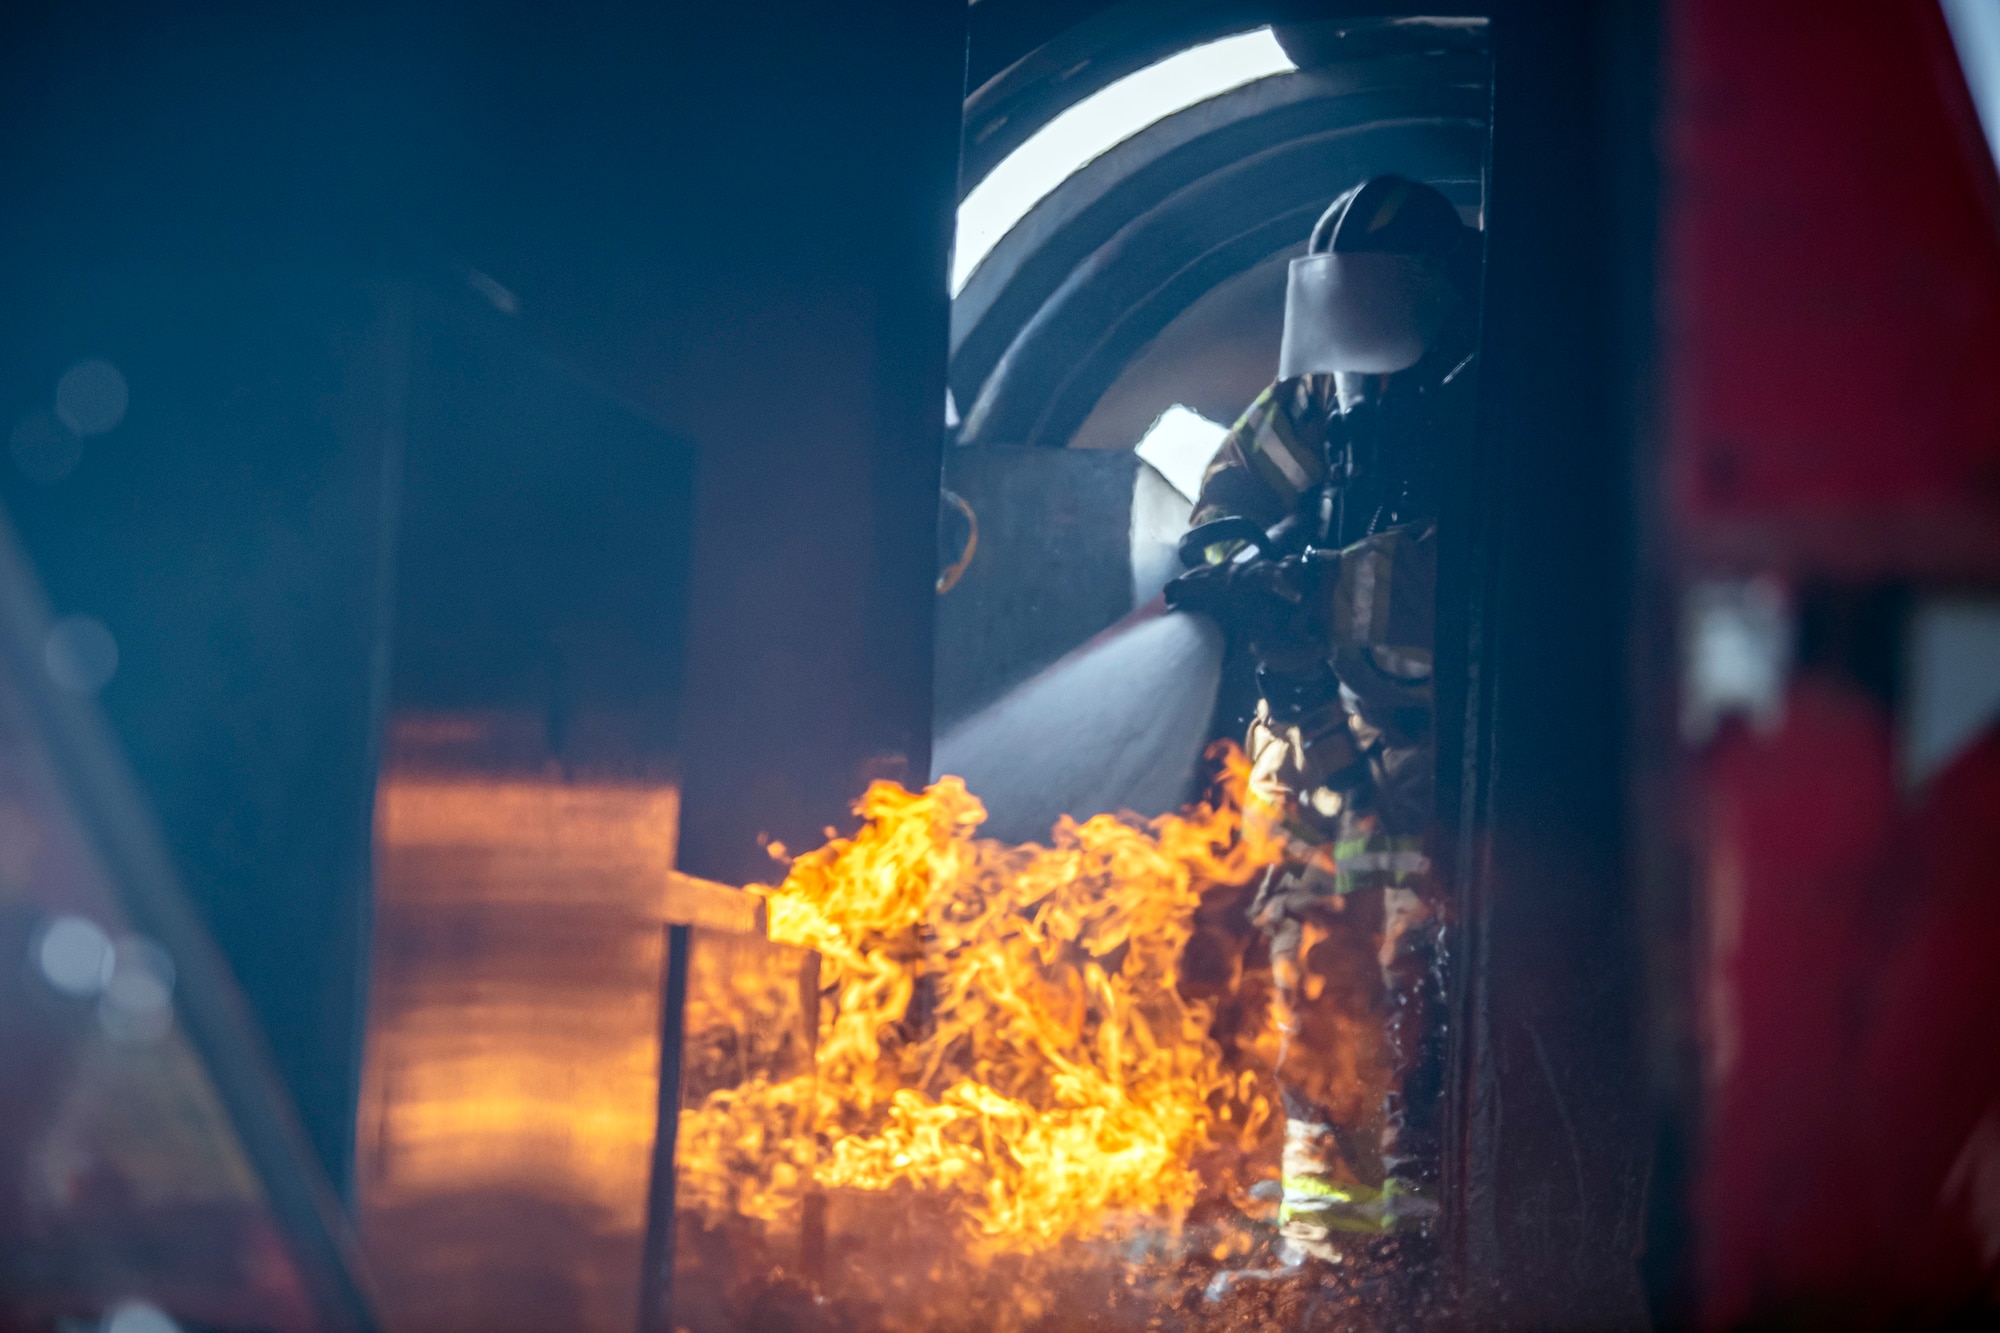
[1696, 696, 2000, 1327]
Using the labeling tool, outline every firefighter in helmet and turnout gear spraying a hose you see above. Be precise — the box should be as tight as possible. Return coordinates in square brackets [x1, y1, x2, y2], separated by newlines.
[1168, 176, 1480, 1261]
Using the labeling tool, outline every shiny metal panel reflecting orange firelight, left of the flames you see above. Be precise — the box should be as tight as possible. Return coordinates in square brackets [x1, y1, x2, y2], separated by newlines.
[358, 771, 678, 1333]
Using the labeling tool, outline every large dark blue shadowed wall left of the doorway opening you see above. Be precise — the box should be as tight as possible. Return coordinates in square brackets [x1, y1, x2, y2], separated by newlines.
[0, 0, 964, 1179]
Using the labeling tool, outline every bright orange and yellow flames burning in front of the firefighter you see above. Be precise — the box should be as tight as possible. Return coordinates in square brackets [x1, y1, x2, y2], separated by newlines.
[676, 749, 1280, 1257]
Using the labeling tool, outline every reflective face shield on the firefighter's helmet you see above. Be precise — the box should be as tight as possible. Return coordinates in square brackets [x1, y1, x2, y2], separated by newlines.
[1278, 250, 1458, 380]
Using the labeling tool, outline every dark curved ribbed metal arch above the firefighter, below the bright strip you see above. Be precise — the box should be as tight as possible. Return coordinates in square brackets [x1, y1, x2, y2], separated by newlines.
[952, 20, 1490, 448]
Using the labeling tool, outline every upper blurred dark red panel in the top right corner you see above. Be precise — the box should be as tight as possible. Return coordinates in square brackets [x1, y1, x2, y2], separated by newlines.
[1666, 0, 2000, 572]
